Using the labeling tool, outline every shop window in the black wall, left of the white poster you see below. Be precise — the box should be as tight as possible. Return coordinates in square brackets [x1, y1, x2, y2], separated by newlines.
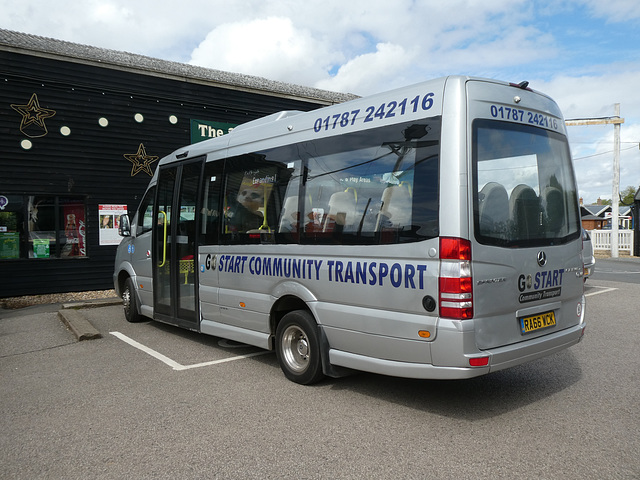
[0, 195, 87, 260]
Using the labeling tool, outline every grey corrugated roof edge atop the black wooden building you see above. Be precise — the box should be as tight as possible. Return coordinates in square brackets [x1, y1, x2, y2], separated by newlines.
[0, 29, 359, 104]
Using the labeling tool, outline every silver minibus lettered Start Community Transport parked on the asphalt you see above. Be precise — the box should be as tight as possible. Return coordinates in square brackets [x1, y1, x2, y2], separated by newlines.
[113, 76, 585, 384]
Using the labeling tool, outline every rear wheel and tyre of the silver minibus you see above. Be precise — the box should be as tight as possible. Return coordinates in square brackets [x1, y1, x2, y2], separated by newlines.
[276, 310, 324, 385]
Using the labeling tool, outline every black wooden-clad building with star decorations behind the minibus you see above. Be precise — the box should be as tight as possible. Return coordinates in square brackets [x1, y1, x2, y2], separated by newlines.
[0, 29, 353, 297]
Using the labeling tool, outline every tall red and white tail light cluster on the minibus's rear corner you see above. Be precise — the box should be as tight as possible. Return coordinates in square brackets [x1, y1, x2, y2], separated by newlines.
[438, 237, 473, 320]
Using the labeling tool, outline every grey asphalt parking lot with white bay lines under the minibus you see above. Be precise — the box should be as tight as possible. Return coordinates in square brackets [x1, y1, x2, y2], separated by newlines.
[0, 280, 640, 479]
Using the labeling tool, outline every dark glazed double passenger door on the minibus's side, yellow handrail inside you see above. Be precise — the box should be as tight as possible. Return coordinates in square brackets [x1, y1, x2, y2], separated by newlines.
[154, 160, 202, 328]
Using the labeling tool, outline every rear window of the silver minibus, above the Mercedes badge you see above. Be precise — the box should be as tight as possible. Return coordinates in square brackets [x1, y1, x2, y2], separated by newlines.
[473, 119, 580, 247]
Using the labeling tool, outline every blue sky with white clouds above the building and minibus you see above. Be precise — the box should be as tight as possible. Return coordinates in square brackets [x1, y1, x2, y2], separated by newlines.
[0, 0, 640, 204]
